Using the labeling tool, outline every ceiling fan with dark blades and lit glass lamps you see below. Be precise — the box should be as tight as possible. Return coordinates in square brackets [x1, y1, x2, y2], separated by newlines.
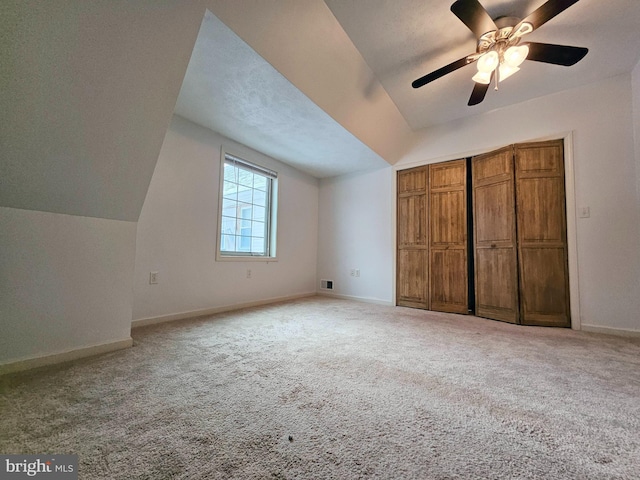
[411, 0, 589, 106]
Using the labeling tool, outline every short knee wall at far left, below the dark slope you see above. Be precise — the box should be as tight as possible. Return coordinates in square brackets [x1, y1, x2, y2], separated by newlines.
[0, 207, 136, 364]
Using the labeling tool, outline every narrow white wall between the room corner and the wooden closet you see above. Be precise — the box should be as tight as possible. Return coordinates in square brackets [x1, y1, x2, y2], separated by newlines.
[318, 167, 395, 303]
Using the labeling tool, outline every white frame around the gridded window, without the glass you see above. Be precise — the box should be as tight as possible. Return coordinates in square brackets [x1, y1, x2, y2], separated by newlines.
[216, 146, 278, 262]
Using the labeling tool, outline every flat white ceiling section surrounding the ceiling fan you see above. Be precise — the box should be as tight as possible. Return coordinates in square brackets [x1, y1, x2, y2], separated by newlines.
[325, 0, 640, 130]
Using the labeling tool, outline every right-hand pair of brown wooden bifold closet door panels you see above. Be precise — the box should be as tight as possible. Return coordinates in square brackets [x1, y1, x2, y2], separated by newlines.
[472, 140, 571, 327]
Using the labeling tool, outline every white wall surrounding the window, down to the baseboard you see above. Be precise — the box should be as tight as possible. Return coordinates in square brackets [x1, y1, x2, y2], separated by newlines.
[133, 116, 318, 320]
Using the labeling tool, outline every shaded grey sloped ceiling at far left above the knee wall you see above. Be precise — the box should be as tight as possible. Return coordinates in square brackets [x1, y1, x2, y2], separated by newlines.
[0, 0, 204, 221]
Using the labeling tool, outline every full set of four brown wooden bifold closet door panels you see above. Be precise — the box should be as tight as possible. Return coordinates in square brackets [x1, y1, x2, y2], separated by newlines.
[396, 140, 571, 327]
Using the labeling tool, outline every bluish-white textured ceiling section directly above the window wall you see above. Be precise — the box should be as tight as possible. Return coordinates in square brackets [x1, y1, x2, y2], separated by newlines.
[175, 11, 388, 178]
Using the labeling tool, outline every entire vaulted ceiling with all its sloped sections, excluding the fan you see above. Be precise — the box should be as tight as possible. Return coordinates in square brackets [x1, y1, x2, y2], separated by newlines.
[0, 0, 640, 221]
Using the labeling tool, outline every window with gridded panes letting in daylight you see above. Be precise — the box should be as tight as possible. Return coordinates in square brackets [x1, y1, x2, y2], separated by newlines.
[218, 150, 278, 258]
